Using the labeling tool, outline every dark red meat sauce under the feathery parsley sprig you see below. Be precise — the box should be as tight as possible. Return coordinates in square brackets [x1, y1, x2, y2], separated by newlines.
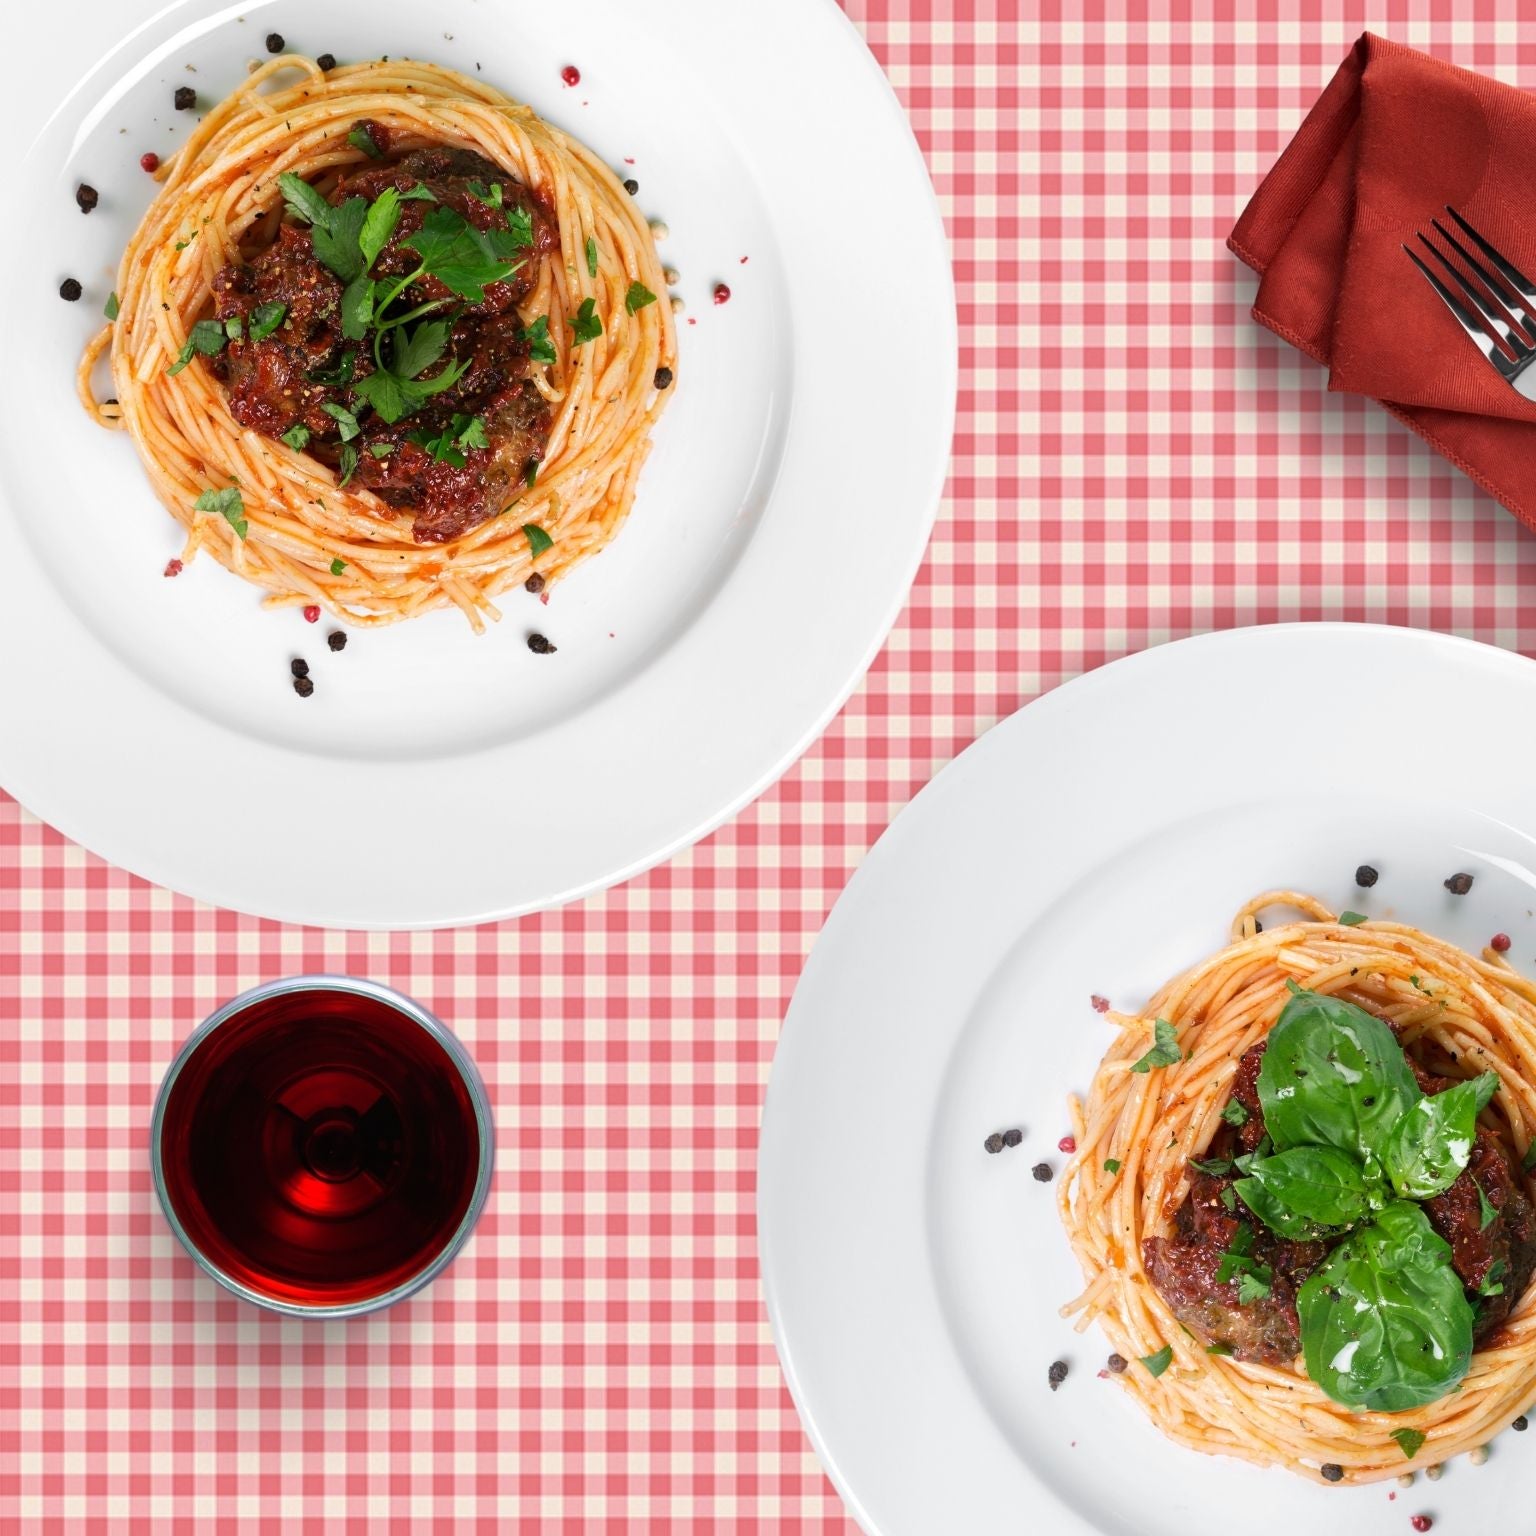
[214, 123, 559, 544]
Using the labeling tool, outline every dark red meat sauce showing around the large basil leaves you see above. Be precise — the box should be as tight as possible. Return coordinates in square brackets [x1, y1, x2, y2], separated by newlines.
[1141, 1043, 1536, 1366]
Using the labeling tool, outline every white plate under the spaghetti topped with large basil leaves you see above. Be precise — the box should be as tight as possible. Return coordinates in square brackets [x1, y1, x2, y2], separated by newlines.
[757, 624, 1536, 1536]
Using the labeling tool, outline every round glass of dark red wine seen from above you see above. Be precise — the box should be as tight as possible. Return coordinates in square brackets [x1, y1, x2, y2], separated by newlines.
[151, 975, 495, 1316]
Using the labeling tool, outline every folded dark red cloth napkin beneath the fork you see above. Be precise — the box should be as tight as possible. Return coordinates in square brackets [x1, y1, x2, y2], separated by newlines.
[1227, 32, 1536, 528]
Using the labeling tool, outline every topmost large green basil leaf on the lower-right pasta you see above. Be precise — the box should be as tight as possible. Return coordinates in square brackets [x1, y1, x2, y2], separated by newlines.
[1258, 989, 1421, 1157]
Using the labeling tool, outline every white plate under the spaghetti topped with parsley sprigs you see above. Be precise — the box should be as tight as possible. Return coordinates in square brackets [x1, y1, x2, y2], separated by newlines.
[0, 0, 955, 928]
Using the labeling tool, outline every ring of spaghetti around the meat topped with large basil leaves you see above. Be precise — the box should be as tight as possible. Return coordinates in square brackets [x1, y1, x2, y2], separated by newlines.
[1058, 891, 1536, 1482]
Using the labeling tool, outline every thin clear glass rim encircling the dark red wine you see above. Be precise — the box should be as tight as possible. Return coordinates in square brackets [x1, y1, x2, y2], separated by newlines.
[149, 972, 496, 1319]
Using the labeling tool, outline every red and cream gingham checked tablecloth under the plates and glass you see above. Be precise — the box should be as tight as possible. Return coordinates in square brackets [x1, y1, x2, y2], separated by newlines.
[0, 0, 1536, 1533]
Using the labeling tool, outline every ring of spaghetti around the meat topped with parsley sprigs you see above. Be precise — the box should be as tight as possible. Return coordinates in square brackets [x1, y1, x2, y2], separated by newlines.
[78, 55, 676, 630]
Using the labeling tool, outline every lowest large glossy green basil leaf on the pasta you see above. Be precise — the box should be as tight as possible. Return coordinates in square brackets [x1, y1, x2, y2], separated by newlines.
[1296, 1201, 1471, 1413]
